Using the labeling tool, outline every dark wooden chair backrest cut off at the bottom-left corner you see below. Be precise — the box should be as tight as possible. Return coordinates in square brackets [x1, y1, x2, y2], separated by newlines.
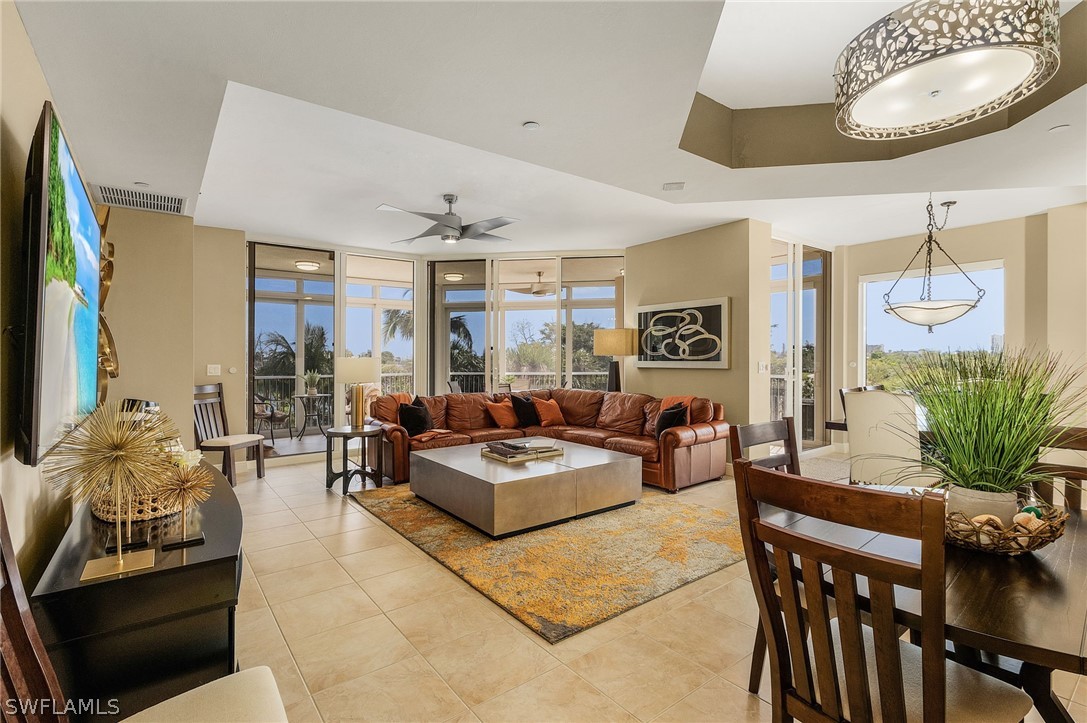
[0, 499, 68, 721]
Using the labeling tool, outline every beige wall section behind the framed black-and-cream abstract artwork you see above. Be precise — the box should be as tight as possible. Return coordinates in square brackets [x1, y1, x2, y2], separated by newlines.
[623, 220, 771, 424]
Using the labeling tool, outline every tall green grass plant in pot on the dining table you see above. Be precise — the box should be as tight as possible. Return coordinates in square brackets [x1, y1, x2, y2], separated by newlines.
[902, 350, 1087, 527]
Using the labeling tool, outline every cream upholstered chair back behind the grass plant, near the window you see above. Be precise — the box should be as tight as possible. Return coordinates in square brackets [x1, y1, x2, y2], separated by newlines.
[846, 391, 927, 485]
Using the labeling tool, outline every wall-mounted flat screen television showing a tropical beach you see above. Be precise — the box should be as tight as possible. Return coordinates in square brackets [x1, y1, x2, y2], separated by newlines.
[15, 101, 102, 465]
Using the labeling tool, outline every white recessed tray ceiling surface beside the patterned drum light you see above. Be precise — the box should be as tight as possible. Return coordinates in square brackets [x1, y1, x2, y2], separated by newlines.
[698, 0, 1080, 108]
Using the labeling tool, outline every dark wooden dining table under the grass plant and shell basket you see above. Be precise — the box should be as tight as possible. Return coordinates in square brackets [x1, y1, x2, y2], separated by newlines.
[762, 486, 1087, 723]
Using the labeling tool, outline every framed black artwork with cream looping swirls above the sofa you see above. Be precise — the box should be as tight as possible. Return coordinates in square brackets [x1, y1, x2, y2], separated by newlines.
[635, 297, 730, 369]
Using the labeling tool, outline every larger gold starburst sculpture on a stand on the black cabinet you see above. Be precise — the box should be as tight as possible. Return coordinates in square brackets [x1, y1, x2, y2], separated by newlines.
[45, 401, 177, 565]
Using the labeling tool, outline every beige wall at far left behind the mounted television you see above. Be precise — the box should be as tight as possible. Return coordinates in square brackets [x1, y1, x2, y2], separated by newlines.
[0, 0, 71, 583]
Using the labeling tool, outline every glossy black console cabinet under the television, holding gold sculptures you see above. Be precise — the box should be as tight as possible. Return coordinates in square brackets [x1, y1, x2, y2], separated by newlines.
[30, 462, 241, 718]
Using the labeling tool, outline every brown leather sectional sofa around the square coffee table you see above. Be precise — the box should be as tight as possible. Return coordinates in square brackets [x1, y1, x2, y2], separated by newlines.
[371, 389, 728, 493]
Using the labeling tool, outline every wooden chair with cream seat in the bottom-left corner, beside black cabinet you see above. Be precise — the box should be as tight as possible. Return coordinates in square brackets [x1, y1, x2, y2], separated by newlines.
[0, 499, 287, 723]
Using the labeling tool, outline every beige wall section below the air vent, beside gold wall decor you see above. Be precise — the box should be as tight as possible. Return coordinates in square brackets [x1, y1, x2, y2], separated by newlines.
[105, 208, 193, 448]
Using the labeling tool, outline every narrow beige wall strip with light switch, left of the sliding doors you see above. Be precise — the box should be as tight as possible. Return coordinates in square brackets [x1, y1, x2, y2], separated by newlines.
[195, 226, 249, 445]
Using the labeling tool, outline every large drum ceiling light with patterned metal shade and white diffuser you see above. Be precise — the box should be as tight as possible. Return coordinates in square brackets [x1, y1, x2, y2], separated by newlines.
[834, 0, 1060, 140]
